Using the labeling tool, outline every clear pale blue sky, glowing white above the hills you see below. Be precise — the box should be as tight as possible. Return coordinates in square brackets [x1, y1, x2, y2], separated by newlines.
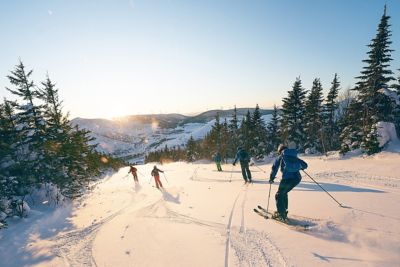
[0, 0, 400, 118]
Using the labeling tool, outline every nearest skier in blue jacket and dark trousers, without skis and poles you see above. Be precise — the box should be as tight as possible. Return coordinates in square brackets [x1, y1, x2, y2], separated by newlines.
[269, 142, 308, 221]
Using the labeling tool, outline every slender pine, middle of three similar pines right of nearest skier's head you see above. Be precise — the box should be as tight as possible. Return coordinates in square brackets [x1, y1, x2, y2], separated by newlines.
[304, 78, 326, 153]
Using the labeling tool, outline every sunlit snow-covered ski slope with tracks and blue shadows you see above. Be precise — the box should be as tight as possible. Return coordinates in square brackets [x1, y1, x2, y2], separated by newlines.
[0, 152, 400, 266]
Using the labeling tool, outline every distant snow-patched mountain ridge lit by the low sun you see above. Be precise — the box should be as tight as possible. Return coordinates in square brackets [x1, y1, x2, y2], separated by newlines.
[72, 108, 272, 162]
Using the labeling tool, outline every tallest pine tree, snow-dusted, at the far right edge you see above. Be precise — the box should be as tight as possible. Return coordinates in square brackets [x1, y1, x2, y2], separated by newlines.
[355, 5, 394, 153]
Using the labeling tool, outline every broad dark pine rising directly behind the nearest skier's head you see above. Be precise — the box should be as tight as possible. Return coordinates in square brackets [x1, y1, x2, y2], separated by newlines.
[281, 78, 307, 151]
